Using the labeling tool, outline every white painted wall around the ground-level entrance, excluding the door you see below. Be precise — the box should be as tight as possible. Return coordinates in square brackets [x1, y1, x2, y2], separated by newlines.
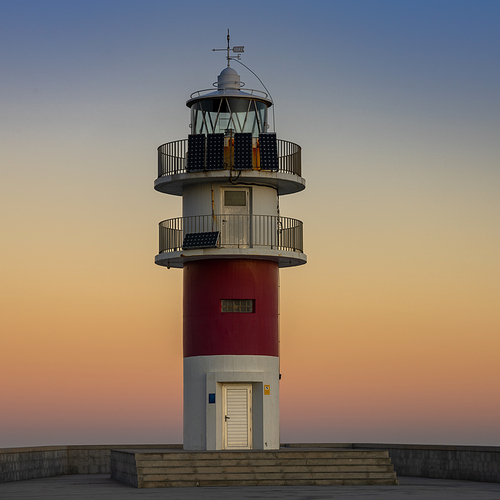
[183, 356, 280, 450]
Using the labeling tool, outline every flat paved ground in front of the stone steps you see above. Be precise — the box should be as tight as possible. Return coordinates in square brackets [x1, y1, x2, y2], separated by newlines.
[0, 474, 500, 500]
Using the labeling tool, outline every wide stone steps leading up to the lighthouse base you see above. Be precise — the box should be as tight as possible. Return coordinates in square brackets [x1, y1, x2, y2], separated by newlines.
[111, 448, 399, 488]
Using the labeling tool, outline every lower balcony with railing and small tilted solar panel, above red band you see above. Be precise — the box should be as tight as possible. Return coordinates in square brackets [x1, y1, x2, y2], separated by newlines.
[155, 214, 307, 268]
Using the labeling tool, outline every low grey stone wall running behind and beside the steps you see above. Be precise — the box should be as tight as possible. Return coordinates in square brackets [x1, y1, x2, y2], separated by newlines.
[0, 443, 500, 486]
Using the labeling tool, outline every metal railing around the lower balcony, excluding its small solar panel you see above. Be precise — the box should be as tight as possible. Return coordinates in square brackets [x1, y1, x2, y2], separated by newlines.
[159, 214, 303, 253]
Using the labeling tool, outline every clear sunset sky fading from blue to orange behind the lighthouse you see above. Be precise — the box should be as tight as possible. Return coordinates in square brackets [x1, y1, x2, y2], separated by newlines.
[0, 0, 500, 448]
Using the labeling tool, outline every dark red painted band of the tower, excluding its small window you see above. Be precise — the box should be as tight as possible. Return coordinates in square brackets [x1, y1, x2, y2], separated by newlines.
[183, 259, 279, 357]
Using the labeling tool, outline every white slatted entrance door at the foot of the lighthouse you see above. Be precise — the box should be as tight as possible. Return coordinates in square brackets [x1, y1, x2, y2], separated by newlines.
[222, 384, 252, 450]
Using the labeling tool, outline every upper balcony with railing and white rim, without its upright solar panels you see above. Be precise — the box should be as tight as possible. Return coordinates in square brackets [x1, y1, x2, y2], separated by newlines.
[154, 137, 306, 196]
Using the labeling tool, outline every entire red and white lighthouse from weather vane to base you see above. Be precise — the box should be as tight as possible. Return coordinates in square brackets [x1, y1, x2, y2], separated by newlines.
[154, 39, 307, 450]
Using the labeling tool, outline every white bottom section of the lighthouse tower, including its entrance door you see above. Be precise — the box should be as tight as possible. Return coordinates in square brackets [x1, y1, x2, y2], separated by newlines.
[183, 355, 280, 450]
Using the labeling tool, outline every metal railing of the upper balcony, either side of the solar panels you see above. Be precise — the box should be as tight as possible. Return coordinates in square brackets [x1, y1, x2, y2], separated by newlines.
[158, 139, 302, 177]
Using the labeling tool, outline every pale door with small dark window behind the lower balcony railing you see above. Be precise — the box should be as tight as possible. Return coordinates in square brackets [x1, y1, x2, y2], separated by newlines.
[221, 187, 250, 248]
